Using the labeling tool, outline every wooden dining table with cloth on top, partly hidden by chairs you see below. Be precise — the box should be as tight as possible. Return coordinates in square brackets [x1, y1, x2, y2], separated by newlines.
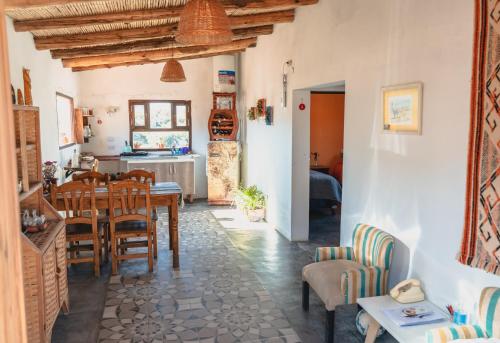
[52, 182, 182, 269]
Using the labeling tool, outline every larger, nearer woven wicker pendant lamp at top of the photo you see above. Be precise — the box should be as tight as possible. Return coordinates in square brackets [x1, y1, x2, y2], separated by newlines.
[176, 0, 233, 45]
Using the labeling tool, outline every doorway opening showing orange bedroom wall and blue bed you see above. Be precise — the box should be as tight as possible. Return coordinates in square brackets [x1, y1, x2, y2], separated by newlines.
[309, 90, 345, 243]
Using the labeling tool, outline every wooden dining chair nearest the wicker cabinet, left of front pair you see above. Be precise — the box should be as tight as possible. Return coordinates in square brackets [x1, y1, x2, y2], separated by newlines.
[51, 181, 101, 277]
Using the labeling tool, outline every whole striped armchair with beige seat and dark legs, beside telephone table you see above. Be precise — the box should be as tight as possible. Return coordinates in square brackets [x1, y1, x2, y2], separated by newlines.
[302, 224, 394, 342]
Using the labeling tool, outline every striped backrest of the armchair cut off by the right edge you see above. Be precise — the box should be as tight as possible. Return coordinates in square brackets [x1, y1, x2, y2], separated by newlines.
[479, 287, 500, 338]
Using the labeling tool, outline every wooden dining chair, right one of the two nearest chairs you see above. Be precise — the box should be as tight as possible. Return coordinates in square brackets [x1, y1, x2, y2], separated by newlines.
[108, 180, 153, 274]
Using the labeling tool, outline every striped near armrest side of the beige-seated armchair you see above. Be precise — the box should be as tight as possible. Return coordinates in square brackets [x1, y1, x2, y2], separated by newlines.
[340, 267, 389, 304]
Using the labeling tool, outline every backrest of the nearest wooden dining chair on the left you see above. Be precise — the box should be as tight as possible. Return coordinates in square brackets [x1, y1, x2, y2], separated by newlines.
[51, 181, 97, 226]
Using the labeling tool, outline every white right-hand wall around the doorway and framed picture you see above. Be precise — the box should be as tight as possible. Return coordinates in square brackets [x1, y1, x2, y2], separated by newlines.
[240, 0, 500, 312]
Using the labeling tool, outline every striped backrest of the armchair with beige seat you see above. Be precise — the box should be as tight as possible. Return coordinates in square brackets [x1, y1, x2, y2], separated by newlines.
[352, 224, 394, 270]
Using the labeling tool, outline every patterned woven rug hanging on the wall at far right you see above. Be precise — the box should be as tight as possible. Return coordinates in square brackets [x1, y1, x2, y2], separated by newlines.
[459, 0, 500, 275]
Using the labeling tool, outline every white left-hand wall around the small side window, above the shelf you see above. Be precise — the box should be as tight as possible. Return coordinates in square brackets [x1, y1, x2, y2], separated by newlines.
[7, 17, 79, 170]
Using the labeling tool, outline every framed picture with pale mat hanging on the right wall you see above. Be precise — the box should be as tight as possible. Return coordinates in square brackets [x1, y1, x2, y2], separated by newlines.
[382, 82, 423, 135]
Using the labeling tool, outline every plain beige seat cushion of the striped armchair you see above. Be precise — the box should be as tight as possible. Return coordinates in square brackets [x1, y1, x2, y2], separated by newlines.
[302, 260, 361, 311]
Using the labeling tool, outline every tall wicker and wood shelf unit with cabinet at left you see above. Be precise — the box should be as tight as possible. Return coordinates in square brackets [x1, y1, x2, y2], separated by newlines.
[14, 106, 69, 343]
